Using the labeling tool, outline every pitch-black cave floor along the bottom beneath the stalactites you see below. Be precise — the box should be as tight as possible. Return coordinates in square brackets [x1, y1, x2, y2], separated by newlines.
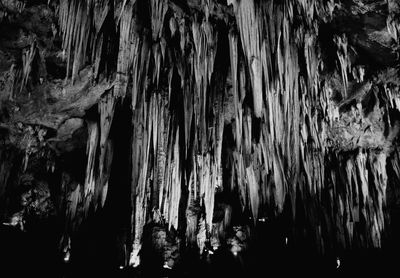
[0, 225, 397, 278]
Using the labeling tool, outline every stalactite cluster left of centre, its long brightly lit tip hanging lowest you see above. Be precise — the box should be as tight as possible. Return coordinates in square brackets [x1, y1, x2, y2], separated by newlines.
[131, 94, 170, 264]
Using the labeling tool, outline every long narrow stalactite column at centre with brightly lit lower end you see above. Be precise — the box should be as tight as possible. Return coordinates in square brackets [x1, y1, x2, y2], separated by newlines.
[185, 15, 219, 235]
